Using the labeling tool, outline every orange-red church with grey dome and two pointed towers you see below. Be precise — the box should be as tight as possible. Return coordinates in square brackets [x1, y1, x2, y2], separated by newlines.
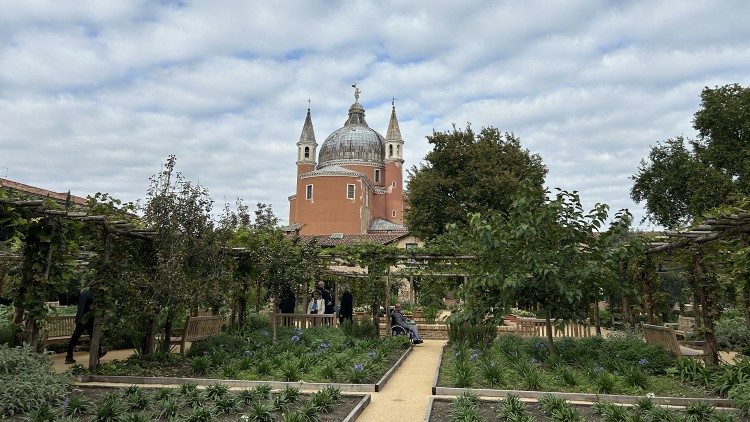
[289, 87, 406, 236]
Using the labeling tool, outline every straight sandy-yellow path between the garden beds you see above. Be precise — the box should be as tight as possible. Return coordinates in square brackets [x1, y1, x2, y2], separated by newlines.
[357, 340, 445, 422]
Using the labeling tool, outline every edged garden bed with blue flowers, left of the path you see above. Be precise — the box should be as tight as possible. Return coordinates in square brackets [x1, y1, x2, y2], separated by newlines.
[92, 327, 412, 392]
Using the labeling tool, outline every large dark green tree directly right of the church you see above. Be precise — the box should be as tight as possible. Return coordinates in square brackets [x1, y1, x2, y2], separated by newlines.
[404, 126, 547, 239]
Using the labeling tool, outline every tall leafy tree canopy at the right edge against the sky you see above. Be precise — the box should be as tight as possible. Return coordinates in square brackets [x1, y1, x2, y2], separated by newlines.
[630, 84, 750, 228]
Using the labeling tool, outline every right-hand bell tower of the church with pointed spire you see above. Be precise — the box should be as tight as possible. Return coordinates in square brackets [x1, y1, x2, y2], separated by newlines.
[384, 98, 404, 225]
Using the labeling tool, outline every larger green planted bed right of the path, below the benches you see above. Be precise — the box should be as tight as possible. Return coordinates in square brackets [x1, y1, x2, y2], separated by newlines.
[433, 335, 744, 406]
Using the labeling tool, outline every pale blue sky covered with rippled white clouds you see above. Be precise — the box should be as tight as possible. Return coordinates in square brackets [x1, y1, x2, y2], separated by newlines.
[0, 0, 750, 227]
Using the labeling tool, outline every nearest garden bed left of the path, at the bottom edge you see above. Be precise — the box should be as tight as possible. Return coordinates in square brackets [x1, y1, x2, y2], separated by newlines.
[4, 384, 370, 422]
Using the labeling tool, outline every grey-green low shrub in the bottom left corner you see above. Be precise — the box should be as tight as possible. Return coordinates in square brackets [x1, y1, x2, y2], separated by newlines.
[0, 345, 70, 416]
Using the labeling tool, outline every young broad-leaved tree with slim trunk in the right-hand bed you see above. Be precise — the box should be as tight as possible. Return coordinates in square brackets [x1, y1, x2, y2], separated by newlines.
[464, 183, 608, 353]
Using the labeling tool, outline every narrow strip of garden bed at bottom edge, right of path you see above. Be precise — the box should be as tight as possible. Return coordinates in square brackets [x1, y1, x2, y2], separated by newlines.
[425, 395, 750, 422]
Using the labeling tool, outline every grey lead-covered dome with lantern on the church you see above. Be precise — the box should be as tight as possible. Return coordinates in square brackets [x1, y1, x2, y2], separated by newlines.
[317, 102, 385, 168]
